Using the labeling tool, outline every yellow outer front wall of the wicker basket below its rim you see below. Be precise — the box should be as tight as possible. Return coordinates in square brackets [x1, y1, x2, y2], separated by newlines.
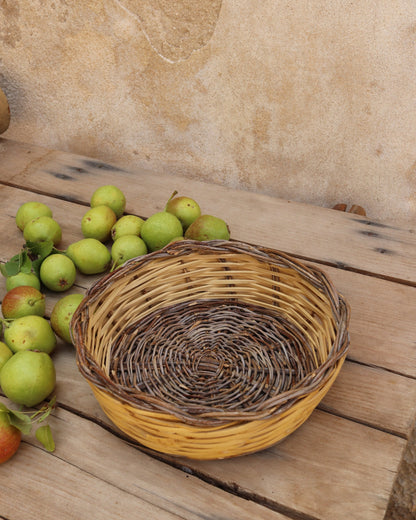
[90, 363, 342, 460]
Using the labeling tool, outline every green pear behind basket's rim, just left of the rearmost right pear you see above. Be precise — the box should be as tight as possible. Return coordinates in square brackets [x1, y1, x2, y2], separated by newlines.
[141, 211, 183, 251]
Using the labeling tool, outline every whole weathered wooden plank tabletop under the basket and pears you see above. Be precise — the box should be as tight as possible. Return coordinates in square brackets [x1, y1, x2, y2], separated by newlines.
[0, 139, 416, 520]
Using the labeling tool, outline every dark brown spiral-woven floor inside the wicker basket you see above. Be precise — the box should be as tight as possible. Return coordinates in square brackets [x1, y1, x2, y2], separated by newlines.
[110, 300, 318, 414]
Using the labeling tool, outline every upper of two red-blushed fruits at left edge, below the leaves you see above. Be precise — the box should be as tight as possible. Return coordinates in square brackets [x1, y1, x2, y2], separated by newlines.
[1, 285, 45, 320]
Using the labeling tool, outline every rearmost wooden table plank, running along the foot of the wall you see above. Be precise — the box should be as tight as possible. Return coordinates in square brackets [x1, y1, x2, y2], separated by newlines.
[0, 139, 416, 285]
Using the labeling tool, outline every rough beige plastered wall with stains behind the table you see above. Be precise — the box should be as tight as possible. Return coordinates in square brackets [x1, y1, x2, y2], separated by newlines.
[0, 0, 416, 225]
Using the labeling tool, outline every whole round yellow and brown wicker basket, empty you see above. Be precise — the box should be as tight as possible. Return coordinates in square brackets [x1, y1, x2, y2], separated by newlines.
[72, 240, 349, 459]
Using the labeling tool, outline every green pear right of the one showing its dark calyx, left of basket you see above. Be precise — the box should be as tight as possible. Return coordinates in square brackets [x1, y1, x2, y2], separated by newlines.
[66, 238, 111, 274]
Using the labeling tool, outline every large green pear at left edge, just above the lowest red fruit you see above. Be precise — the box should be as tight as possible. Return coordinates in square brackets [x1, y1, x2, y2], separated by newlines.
[0, 350, 56, 407]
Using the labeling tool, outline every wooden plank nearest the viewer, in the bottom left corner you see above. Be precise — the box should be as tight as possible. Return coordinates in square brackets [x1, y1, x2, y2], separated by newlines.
[0, 408, 287, 520]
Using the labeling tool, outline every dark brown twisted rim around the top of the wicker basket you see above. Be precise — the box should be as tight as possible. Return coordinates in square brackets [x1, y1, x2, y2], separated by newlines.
[71, 240, 350, 425]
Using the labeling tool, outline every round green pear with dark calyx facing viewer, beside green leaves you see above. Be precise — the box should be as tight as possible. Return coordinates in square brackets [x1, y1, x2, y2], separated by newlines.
[39, 253, 77, 292]
